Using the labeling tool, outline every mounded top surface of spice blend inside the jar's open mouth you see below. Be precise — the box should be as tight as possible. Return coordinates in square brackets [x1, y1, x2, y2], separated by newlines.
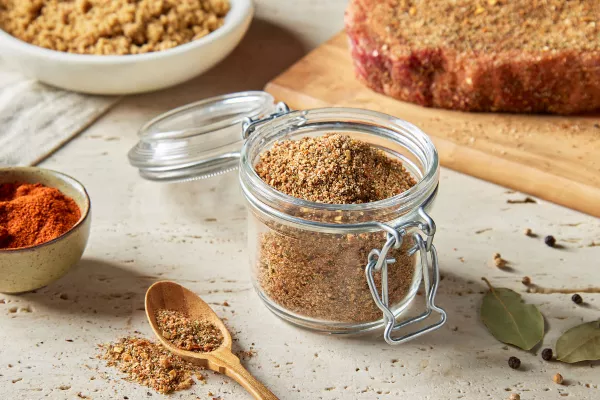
[255, 134, 416, 204]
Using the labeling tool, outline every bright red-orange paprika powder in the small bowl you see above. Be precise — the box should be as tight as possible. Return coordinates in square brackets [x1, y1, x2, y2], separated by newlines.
[0, 183, 81, 249]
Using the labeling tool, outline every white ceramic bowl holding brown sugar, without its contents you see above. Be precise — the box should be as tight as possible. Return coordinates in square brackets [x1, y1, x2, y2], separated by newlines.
[0, 0, 254, 95]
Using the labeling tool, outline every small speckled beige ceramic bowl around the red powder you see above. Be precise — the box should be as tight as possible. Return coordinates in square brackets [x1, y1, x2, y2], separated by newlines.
[0, 167, 92, 293]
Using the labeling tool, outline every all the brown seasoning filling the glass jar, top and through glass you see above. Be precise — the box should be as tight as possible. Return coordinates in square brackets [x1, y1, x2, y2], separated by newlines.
[255, 133, 416, 323]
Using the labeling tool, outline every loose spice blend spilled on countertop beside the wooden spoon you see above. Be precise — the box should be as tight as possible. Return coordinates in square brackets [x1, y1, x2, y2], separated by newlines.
[99, 337, 204, 394]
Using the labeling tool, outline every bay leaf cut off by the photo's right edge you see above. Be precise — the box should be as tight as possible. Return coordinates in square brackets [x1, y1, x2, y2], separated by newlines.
[556, 320, 600, 363]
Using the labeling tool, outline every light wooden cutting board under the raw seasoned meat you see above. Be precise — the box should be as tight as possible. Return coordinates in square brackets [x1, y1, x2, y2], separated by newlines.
[266, 33, 600, 217]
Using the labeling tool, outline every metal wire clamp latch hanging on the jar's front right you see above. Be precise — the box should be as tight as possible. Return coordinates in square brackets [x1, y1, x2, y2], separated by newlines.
[365, 197, 446, 344]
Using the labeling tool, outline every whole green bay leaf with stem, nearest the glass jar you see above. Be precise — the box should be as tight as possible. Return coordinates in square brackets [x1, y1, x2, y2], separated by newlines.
[480, 278, 544, 350]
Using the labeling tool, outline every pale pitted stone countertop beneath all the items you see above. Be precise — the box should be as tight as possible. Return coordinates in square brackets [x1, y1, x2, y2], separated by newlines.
[0, 0, 600, 400]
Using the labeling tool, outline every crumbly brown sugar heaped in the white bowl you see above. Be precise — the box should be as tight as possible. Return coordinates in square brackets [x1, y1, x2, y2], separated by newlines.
[0, 0, 230, 55]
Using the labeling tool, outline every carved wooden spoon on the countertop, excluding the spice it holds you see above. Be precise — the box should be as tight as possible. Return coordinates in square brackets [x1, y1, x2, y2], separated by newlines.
[146, 281, 277, 400]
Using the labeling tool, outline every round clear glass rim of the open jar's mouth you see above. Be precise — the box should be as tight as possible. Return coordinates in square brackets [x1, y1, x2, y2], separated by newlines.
[240, 107, 439, 219]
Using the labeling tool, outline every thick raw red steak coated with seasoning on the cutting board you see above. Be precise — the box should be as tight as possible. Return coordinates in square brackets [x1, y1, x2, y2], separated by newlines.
[345, 0, 600, 114]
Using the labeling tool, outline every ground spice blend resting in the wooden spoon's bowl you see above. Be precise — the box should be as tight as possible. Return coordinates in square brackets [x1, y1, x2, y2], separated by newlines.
[156, 310, 223, 353]
